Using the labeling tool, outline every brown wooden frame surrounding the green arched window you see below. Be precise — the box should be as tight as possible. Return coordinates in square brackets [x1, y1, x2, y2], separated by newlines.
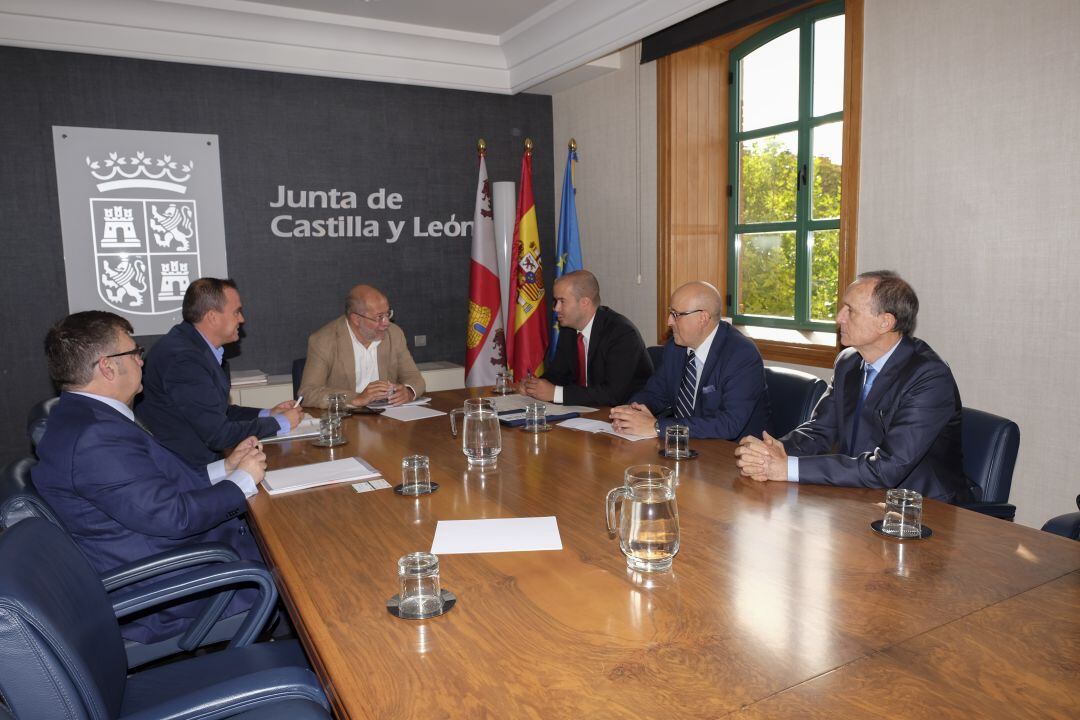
[657, 0, 863, 367]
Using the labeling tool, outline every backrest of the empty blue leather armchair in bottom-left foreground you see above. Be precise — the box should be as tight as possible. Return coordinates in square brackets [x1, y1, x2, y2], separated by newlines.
[0, 518, 127, 718]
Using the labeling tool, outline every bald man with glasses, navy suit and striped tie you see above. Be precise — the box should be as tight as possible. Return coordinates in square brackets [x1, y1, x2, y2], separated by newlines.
[611, 282, 769, 439]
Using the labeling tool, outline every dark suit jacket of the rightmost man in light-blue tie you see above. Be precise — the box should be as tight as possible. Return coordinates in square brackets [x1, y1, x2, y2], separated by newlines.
[781, 337, 973, 502]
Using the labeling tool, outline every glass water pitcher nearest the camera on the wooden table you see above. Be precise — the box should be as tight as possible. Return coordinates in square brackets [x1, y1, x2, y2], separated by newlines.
[606, 465, 679, 572]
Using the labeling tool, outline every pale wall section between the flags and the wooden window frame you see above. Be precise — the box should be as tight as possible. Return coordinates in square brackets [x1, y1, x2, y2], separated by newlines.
[552, 47, 657, 345]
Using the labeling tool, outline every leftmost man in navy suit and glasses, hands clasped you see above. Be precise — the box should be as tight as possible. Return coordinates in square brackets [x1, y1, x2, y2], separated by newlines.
[31, 311, 266, 643]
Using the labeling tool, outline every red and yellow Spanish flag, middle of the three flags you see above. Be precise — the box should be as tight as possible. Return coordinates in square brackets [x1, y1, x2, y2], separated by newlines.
[507, 140, 548, 381]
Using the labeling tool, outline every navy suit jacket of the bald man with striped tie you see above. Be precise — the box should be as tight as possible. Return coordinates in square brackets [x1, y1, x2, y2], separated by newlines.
[630, 322, 770, 440]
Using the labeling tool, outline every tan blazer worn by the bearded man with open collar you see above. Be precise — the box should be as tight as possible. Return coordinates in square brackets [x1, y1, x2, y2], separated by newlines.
[300, 315, 424, 408]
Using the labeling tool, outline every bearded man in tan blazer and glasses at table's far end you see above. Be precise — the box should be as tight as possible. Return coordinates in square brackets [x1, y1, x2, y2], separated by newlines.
[300, 285, 424, 408]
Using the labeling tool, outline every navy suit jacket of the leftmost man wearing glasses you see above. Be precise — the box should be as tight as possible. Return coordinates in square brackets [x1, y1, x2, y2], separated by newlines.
[31, 393, 262, 643]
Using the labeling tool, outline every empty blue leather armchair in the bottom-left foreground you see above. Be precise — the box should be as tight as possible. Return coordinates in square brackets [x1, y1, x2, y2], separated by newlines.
[0, 518, 327, 720]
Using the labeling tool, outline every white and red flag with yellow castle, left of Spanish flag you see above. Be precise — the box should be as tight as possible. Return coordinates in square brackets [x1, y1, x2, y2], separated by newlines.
[465, 150, 505, 388]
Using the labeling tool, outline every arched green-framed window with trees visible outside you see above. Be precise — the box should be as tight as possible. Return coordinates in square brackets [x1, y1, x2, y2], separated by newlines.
[727, 2, 845, 331]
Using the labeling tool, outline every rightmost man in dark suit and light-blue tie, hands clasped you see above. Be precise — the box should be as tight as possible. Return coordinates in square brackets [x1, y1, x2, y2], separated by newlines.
[735, 270, 977, 502]
